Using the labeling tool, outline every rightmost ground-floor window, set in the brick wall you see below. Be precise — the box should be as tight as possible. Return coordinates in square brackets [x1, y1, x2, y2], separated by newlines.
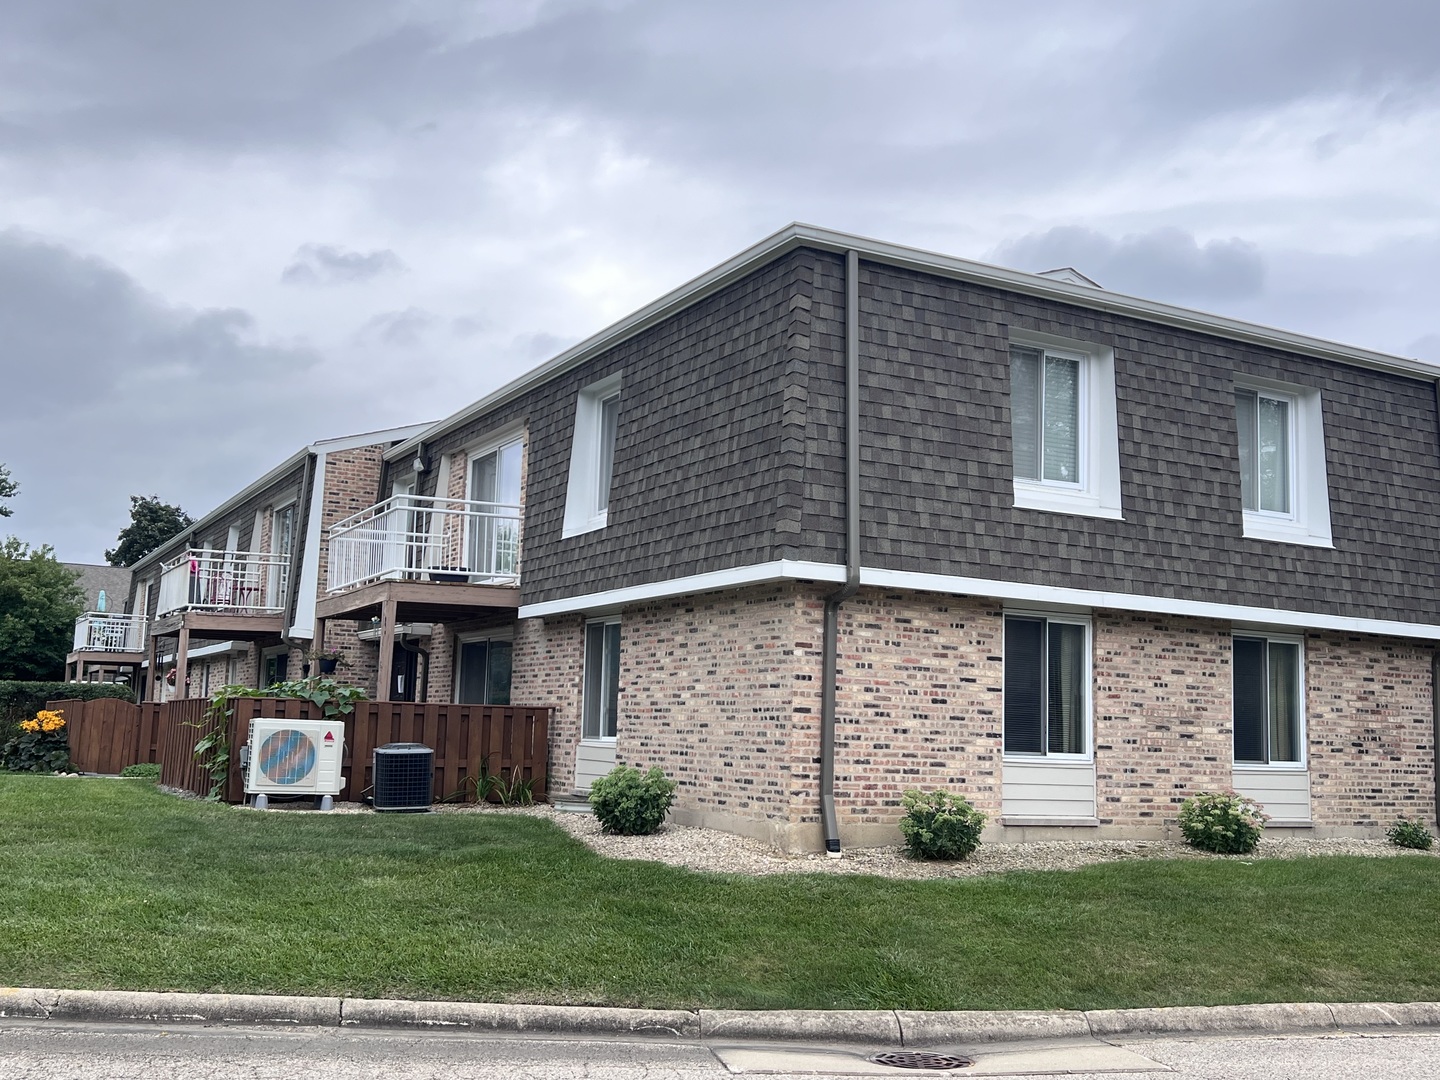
[1234, 635, 1305, 765]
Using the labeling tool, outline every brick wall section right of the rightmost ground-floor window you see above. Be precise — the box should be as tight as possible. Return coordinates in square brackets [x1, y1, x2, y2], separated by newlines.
[1305, 634, 1436, 828]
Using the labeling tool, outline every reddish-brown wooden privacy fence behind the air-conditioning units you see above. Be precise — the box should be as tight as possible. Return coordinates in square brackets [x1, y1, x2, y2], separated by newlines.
[49, 697, 550, 802]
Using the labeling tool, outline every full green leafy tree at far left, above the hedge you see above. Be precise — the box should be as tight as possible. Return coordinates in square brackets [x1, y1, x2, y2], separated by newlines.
[0, 536, 85, 680]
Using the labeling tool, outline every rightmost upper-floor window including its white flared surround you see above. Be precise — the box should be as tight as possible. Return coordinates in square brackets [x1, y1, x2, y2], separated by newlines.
[1236, 379, 1331, 547]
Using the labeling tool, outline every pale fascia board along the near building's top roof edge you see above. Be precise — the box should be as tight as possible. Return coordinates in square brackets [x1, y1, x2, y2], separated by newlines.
[386, 222, 1440, 459]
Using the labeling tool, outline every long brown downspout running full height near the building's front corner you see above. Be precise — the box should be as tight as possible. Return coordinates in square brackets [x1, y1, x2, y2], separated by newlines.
[819, 251, 860, 858]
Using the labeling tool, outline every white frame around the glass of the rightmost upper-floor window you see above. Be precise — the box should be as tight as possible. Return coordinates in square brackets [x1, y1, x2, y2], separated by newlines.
[1231, 374, 1335, 547]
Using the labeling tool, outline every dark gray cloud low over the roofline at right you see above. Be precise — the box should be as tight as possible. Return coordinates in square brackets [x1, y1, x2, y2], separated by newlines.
[991, 225, 1266, 302]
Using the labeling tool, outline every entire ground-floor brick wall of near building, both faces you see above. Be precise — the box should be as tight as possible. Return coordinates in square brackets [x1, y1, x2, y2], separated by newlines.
[513, 585, 1434, 848]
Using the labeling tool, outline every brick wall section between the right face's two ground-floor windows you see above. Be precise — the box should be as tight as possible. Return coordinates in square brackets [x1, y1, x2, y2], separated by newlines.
[1093, 612, 1234, 827]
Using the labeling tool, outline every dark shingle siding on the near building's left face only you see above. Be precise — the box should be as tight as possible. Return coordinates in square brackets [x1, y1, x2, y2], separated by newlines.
[426, 252, 811, 603]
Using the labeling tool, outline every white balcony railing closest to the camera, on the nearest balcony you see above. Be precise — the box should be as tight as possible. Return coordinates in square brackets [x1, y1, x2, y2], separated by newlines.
[325, 495, 520, 592]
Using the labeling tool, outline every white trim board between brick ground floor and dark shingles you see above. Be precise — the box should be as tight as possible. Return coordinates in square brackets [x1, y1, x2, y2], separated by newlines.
[518, 559, 1440, 641]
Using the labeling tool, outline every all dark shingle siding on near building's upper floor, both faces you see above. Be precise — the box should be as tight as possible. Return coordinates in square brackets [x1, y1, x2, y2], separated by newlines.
[426, 249, 1440, 622]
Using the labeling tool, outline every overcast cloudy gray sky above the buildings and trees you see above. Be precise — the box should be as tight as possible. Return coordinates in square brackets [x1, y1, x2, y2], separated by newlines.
[0, 0, 1440, 562]
